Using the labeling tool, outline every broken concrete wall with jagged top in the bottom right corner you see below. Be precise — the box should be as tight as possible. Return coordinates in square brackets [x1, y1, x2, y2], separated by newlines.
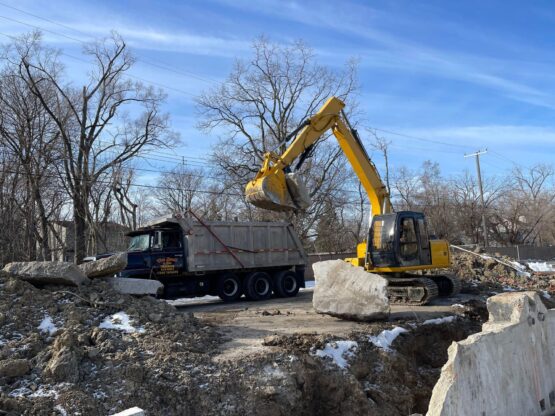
[427, 292, 555, 416]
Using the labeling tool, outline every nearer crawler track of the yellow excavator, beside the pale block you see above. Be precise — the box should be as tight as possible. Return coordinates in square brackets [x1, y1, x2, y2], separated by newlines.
[386, 275, 439, 306]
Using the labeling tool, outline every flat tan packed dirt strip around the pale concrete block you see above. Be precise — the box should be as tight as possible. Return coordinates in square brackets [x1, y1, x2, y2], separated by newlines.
[170, 288, 478, 361]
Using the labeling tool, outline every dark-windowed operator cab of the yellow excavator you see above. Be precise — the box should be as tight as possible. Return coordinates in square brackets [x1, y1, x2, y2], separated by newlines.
[366, 211, 432, 268]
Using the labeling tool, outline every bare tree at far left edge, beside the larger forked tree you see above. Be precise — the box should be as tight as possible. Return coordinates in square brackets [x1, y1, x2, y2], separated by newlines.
[0, 35, 67, 260]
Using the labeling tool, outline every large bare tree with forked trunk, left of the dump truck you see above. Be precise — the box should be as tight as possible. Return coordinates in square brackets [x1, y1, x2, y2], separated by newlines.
[9, 34, 176, 262]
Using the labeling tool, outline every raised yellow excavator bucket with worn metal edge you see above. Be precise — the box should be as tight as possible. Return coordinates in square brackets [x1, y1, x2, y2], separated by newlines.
[245, 170, 311, 211]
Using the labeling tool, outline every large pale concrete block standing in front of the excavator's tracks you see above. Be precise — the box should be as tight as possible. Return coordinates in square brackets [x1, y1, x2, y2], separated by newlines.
[312, 260, 389, 321]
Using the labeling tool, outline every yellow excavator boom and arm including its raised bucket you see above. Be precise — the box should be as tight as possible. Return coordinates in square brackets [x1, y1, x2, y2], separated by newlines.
[245, 97, 393, 216]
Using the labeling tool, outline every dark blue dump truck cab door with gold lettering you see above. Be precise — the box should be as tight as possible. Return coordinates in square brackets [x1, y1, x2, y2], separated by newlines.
[151, 229, 184, 280]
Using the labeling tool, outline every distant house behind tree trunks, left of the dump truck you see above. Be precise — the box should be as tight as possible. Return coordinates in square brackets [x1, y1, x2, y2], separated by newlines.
[48, 221, 131, 262]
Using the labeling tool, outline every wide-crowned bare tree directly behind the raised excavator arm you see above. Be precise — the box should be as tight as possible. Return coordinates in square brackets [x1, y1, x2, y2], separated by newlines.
[197, 38, 358, 245]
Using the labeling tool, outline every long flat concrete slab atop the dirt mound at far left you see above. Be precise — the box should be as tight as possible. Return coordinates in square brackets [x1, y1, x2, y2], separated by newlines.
[4, 261, 89, 286]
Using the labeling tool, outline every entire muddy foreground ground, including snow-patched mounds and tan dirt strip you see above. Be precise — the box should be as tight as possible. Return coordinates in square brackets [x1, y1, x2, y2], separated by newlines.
[0, 250, 548, 416]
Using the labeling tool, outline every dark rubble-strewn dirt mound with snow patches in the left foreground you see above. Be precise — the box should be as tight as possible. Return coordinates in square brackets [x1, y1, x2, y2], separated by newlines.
[0, 274, 220, 415]
